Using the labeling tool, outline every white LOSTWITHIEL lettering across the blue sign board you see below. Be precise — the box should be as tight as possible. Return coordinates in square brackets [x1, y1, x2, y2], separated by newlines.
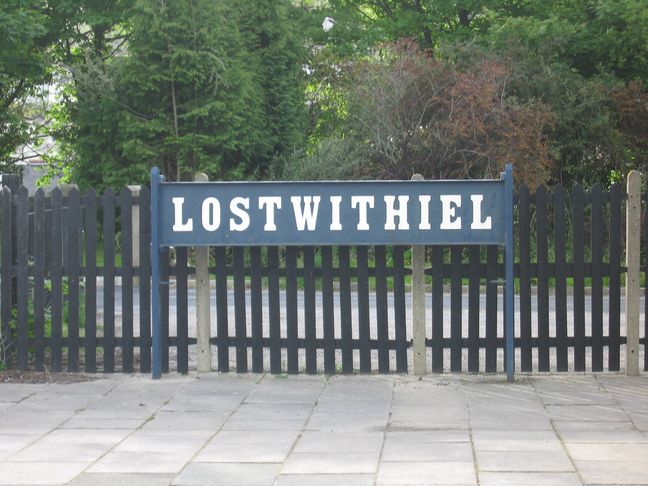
[171, 194, 493, 233]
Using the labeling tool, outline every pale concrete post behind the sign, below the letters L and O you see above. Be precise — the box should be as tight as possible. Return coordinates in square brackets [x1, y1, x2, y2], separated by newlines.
[194, 173, 211, 373]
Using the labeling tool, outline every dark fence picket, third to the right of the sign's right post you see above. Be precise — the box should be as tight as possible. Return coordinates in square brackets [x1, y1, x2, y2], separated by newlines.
[553, 186, 569, 371]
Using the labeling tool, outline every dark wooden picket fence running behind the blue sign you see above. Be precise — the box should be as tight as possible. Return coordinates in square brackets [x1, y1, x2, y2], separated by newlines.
[0, 180, 648, 373]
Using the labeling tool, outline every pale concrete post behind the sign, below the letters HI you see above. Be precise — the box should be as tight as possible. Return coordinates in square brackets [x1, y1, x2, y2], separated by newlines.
[412, 174, 427, 376]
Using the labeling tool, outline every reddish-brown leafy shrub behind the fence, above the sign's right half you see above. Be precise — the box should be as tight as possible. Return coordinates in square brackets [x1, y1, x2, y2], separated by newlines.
[349, 42, 553, 186]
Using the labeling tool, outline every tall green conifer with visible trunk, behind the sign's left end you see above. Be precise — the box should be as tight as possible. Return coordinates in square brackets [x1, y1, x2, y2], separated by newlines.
[72, 0, 261, 186]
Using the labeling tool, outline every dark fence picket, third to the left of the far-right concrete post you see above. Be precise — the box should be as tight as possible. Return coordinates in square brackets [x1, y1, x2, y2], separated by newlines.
[572, 184, 585, 371]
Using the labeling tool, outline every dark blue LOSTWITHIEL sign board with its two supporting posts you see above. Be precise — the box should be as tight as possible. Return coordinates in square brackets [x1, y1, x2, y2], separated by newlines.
[151, 165, 514, 381]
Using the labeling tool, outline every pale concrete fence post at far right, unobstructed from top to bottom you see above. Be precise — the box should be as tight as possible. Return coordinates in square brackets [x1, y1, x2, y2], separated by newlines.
[625, 170, 641, 376]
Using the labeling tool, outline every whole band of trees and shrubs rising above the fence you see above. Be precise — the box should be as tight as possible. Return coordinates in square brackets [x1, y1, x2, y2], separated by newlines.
[0, 0, 648, 187]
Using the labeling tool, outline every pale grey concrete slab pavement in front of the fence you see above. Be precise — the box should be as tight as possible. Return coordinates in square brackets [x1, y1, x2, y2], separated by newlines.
[0, 374, 648, 486]
